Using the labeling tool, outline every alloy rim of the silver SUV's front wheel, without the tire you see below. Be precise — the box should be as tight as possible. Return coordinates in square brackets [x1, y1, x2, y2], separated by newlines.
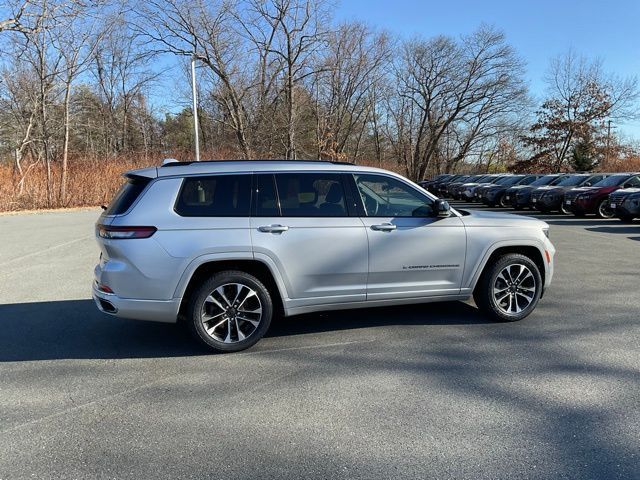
[493, 263, 537, 315]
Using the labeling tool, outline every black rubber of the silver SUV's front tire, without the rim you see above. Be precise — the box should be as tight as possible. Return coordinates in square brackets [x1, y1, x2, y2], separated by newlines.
[473, 253, 542, 322]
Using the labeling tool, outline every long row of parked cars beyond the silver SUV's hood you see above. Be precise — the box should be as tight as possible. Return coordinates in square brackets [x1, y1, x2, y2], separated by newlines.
[420, 172, 640, 222]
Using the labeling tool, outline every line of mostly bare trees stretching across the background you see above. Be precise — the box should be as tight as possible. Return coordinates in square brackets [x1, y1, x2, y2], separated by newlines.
[0, 0, 638, 206]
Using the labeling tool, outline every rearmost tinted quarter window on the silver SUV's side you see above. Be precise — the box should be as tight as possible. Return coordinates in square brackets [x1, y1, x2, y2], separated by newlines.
[175, 175, 251, 217]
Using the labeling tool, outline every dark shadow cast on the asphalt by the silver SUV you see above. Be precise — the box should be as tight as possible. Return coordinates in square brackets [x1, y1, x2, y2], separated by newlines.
[0, 300, 487, 362]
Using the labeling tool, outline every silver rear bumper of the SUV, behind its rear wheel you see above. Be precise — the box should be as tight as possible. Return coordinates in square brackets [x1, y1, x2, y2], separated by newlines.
[93, 283, 182, 323]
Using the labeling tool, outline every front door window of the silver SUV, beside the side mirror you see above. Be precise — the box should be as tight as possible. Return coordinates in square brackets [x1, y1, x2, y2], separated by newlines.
[354, 175, 433, 217]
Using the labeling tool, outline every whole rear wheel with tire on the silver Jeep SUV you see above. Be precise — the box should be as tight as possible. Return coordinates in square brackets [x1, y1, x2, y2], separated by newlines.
[189, 271, 273, 352]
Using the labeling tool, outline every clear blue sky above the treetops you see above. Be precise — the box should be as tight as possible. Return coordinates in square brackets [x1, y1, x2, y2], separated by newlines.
[335, 0, 640, 139]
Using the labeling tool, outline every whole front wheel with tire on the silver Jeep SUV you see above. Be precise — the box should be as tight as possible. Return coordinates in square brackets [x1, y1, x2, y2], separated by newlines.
[473, 253, 542, 322]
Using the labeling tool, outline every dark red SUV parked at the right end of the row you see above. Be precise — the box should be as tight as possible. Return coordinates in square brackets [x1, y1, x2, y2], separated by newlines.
[563, 173, 640, 218]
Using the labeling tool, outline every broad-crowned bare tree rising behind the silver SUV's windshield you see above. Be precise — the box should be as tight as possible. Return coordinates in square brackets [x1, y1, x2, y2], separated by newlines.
[388, 27, 526, 179]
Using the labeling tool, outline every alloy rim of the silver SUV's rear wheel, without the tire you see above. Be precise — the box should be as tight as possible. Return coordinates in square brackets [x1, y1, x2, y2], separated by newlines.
[200, 283, 262, 343]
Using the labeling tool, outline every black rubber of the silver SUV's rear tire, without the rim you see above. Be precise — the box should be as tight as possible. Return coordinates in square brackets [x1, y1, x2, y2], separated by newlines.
[186, 270, 273, 353]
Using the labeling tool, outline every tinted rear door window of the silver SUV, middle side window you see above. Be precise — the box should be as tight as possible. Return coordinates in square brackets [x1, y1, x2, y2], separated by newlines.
[276, 173, 347, 217]
